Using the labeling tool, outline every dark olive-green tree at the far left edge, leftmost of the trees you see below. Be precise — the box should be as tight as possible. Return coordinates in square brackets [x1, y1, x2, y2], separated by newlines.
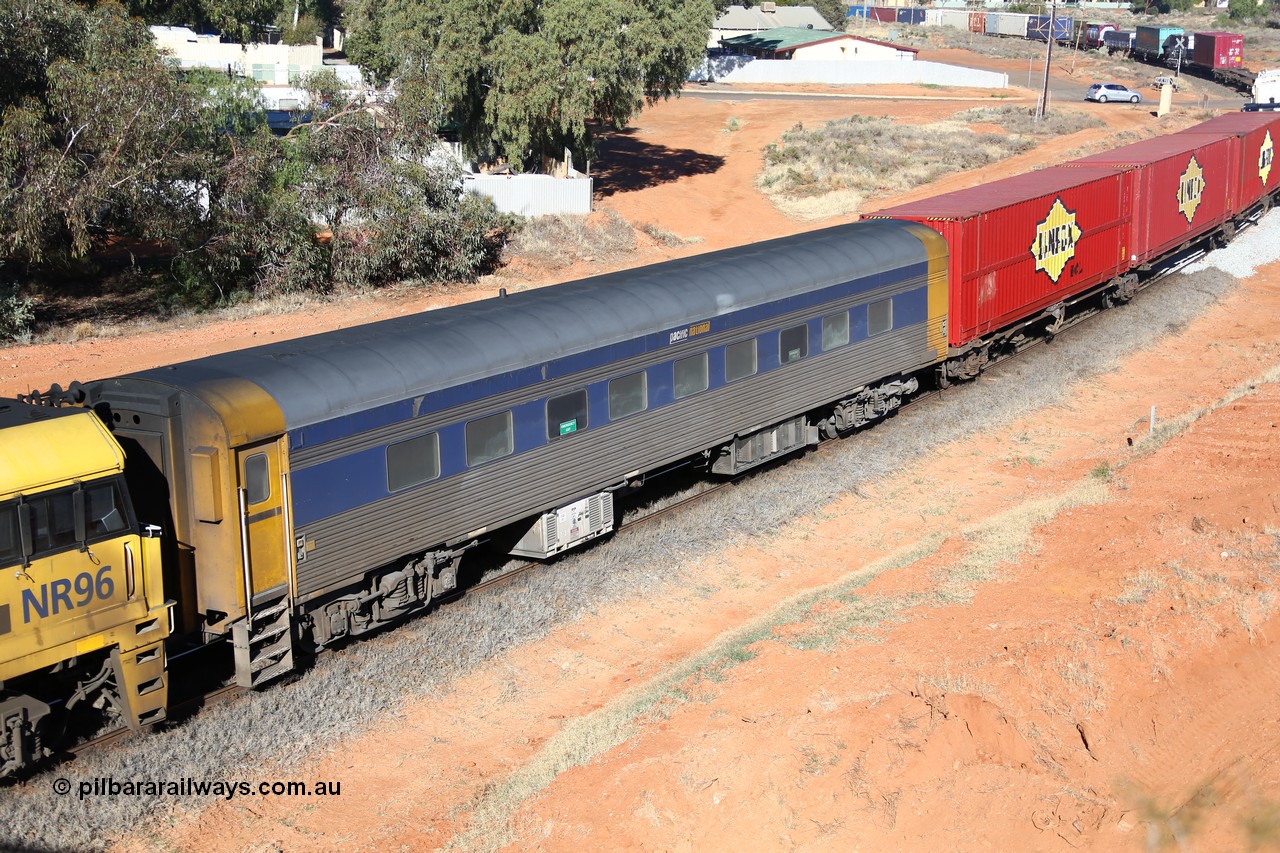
[0, 0, 197, 261]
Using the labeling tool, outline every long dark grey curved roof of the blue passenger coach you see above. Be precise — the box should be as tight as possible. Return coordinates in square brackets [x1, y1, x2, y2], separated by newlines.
[131, 220, 925, 429]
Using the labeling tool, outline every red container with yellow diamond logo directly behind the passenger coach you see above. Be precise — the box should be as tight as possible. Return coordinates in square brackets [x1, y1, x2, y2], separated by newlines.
[870, 167, 1133, 347]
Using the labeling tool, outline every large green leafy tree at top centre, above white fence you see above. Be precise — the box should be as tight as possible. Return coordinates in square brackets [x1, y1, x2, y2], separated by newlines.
[347, 0, 714, 168]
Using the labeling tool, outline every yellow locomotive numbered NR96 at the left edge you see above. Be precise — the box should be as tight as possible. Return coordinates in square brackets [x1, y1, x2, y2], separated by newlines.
[0, 400, 172, 776]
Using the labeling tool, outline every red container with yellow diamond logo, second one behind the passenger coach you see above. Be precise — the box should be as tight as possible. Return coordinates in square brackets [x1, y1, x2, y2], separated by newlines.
[1064, 133, 1240, 264]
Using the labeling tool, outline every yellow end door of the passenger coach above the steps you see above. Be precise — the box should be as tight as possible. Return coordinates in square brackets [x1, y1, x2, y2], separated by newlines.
[236, 439, 289, 604]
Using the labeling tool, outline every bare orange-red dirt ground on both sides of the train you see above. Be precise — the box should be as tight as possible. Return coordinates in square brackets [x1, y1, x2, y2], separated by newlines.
[12, 49, 1280, 850]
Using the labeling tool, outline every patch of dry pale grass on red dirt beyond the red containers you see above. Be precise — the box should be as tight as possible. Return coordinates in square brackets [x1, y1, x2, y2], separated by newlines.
[755, 106, 1100, 219]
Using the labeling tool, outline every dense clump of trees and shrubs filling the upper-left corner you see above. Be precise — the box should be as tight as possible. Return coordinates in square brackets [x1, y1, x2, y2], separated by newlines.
[0, 0, 506, 304]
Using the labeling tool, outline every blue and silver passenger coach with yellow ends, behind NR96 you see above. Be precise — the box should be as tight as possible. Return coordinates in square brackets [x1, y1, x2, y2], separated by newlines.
[91, 222, 947, 684]
